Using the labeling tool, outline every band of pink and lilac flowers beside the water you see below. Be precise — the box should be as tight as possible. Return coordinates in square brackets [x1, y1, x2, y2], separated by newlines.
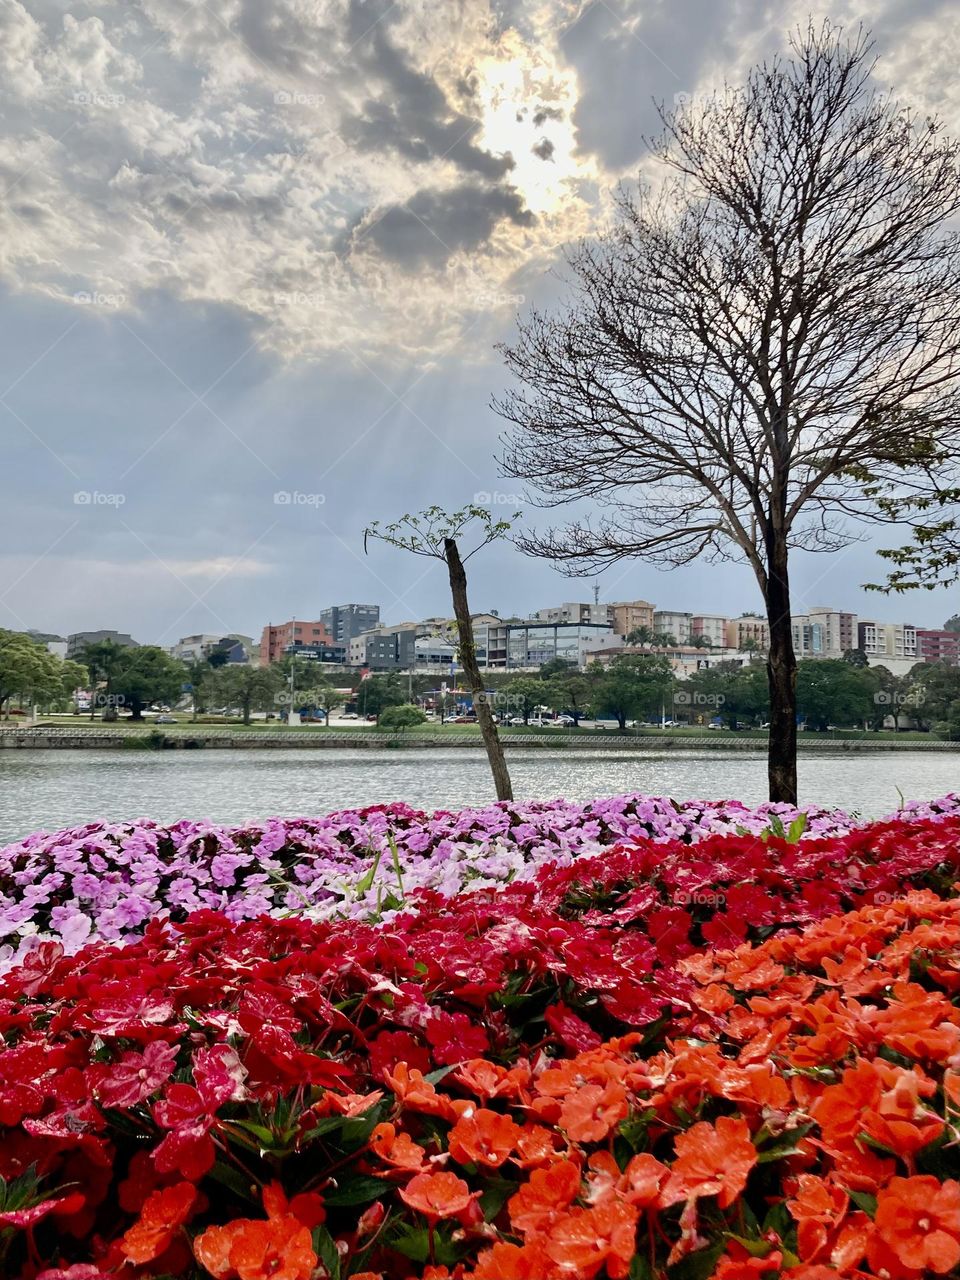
[0, 795, 960, 972]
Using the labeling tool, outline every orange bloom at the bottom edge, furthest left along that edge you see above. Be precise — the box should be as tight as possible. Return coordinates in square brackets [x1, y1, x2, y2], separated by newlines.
[193, 1215, 317, 1280]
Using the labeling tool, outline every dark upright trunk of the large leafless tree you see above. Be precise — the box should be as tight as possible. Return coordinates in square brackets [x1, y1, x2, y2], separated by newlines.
[765, 535, 797, 804]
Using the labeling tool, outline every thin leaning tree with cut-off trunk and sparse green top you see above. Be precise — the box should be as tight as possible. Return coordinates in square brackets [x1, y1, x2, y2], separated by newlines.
[364, 507, 520, 800]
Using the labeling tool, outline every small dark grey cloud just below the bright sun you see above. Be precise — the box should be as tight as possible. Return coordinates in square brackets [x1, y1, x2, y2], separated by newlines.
[338, 182, 534, 269]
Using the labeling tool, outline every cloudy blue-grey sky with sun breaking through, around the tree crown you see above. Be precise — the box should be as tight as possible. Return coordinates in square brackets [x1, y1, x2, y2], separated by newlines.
[0, 0, 960, 645]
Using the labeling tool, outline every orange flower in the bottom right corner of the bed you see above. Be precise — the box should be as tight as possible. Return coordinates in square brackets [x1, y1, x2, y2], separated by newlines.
[874, 1175, 960, 1275]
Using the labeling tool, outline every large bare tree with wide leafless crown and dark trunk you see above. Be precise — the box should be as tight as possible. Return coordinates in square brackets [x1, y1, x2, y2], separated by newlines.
[495, 24, 960, 801]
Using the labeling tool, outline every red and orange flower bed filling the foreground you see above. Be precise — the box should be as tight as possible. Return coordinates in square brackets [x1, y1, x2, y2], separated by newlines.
[0, 806, 960, 1280]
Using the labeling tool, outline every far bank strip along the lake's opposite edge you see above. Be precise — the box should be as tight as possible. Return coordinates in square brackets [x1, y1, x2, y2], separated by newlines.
[0, 723, 960, 754]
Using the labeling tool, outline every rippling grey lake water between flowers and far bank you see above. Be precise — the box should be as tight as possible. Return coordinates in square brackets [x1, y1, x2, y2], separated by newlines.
[0, 748, 960, 844]
